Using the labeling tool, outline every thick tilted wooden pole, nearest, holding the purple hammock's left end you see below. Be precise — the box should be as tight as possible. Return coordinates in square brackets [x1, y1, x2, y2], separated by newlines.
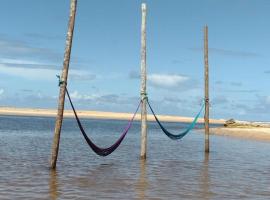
[51, 0, 77, 169]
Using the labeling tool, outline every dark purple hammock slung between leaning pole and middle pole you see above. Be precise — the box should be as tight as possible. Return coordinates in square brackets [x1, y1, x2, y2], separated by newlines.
[66, 88, 141, 156]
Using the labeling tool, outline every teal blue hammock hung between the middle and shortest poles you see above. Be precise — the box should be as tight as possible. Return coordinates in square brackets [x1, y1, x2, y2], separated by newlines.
[147, 100, 204, 140]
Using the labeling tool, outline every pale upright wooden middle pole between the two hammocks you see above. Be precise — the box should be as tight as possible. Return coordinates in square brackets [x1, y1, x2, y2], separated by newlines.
[140, 3, 147, 159]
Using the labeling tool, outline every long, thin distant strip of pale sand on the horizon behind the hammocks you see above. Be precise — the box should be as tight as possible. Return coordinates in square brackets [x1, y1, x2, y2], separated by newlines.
[0, 107, 225, 124]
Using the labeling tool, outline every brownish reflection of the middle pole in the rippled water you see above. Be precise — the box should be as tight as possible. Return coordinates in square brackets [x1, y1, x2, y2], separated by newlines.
[137, 159, 148, 200]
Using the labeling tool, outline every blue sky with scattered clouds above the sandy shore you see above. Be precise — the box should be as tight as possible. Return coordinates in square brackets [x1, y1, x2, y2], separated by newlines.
[0, 0, 270, 121]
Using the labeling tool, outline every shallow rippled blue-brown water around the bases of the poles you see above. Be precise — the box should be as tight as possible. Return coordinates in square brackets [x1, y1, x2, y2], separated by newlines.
[0, 116, 270, 200]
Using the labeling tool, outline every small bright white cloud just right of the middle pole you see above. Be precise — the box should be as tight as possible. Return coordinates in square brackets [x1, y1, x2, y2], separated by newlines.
[148, 74, 189, 88]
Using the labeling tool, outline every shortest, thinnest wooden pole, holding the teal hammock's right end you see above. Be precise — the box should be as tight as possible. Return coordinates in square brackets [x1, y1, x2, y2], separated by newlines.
[204, 26, 209, 153]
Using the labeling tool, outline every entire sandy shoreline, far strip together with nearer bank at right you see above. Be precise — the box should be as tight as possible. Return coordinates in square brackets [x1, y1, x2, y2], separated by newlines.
[0, 107, 270, 142]
